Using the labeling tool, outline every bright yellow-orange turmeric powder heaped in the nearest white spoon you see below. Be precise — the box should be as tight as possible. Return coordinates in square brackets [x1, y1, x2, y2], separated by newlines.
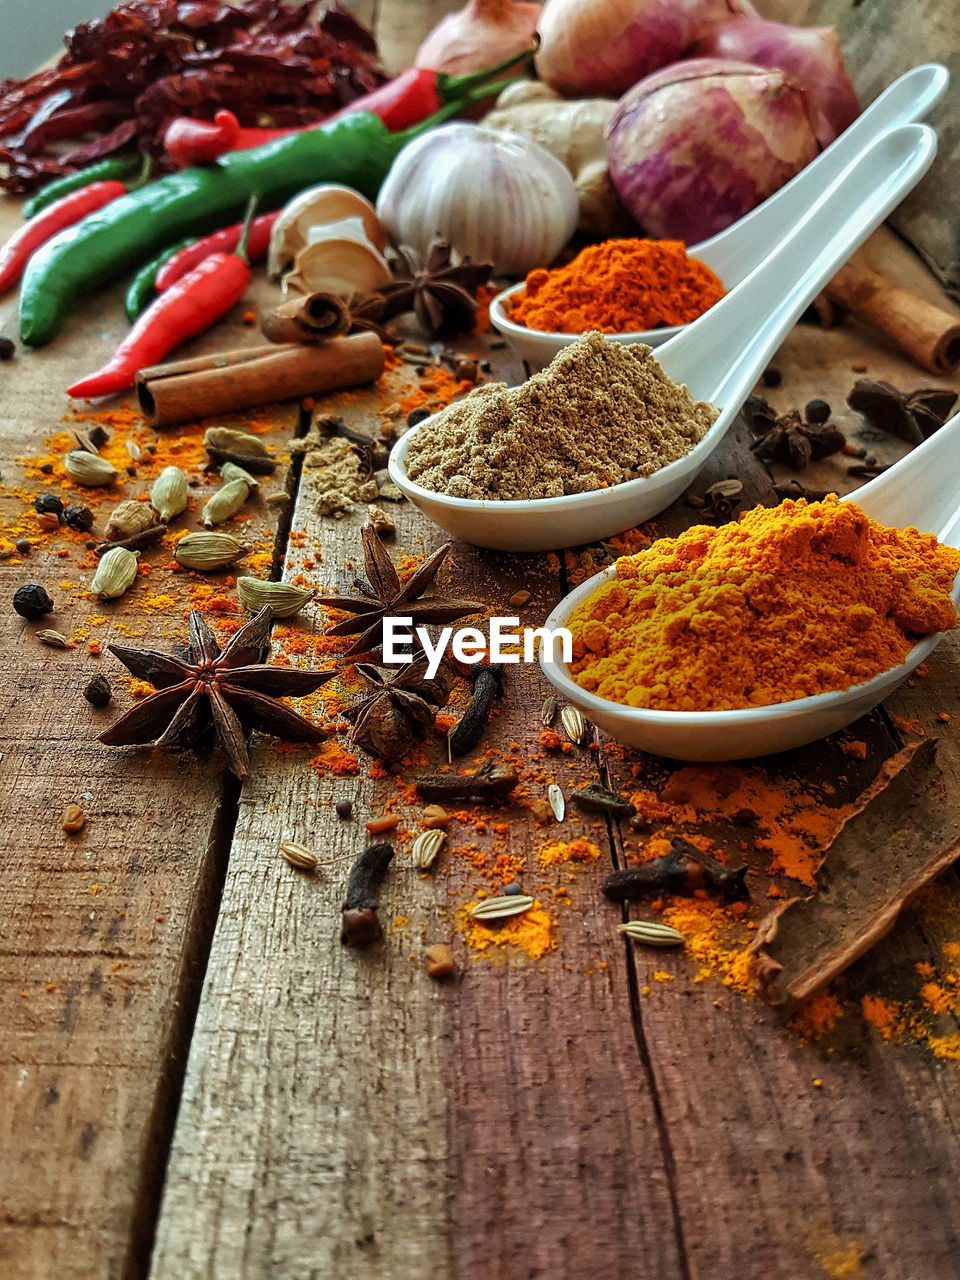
[570, 494, 960, 710]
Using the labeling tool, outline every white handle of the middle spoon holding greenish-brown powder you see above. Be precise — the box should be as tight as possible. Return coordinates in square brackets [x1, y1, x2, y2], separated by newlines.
[657, 124, 937, 411]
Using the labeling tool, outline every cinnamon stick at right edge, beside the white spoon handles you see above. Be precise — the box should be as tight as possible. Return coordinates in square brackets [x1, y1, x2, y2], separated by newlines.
[827, 257, 960, 375]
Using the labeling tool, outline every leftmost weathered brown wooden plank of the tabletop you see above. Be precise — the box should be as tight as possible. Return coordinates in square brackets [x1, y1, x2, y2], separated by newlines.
[0, 192, 297, 1280]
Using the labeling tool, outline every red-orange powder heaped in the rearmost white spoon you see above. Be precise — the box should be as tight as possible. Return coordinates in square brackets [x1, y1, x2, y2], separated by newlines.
[509, 239, 726, 333]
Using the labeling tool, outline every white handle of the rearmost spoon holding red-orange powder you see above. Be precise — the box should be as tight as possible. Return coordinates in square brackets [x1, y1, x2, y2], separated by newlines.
[690, 63, 950, 280]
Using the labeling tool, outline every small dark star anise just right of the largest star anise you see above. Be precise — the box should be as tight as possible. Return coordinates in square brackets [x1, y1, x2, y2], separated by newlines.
[343, 658, 449, 762]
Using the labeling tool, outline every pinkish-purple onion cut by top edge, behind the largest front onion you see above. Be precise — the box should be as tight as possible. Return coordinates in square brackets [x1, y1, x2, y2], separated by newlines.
[536, 0, 755, 97]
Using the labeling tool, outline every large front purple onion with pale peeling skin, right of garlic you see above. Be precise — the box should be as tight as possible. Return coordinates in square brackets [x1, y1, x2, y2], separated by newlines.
[607, 58, 818, 244]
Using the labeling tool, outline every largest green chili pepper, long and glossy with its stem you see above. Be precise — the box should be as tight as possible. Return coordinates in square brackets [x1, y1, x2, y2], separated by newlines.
[20, 81, 512, 347]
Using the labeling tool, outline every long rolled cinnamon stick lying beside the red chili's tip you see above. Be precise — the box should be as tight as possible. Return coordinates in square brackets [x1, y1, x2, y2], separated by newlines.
[137, 333, 385, 426]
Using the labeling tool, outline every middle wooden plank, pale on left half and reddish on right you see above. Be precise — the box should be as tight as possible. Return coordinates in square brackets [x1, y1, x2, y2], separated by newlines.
[152, 335, 681, 1280]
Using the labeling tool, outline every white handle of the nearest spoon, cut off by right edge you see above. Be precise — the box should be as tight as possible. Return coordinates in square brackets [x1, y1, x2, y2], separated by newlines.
[847, 413, 960, 547]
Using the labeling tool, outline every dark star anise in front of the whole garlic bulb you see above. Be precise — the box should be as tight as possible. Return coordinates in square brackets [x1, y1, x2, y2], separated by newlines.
[379, 239, 493, 337]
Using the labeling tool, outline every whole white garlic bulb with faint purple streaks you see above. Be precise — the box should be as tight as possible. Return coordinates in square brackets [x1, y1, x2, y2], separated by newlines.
[376, 123, 579, 275]
